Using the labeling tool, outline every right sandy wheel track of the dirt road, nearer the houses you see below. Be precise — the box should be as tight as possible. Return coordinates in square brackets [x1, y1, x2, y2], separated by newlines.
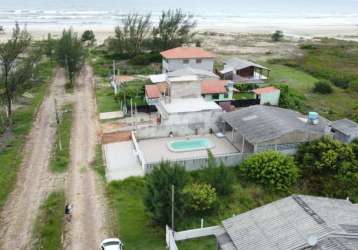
[64, 66, 106, 250]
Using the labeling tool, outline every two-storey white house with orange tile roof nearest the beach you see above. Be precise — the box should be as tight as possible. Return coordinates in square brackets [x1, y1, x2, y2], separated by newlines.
[160, 47, 215, 73]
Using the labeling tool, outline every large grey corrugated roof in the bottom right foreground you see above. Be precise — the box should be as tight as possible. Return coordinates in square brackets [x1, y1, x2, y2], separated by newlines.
[219, 195, 358, 250]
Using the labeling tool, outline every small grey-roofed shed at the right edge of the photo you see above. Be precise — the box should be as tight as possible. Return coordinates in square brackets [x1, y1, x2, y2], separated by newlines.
[332, 119, 358, 143]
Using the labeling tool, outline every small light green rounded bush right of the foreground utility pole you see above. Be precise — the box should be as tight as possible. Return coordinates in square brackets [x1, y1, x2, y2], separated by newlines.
[184, 183, 217, 213]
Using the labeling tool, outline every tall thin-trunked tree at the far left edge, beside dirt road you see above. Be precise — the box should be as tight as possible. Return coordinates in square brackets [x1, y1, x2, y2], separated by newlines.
[0, 24, 31, 121]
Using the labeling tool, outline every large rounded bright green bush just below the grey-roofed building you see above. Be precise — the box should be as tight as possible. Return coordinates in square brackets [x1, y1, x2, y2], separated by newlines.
[239, 151, 299, 191]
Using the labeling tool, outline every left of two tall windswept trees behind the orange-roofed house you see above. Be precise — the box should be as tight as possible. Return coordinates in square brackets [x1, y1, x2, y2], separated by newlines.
[109, 14, 152, 57]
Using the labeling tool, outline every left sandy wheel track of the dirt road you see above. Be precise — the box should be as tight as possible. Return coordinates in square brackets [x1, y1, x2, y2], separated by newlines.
[0, 69, 66, 249]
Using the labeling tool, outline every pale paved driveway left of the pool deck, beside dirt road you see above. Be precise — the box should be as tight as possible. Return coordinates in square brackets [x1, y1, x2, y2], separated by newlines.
[104, 141, 144, 182]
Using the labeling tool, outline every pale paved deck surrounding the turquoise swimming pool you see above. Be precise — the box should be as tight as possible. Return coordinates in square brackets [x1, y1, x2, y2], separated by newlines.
[138, 135, 238, 163]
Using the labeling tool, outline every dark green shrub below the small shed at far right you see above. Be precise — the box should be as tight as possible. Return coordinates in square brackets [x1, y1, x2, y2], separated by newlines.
[297, 136, 355, 175]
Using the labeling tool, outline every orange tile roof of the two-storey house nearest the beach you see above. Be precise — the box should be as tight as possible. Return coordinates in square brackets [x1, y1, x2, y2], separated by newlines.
[160, 47, 215, 59]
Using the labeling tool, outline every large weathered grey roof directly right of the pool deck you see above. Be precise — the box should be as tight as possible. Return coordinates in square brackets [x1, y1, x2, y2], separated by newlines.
[222, 105, 328, 144]
